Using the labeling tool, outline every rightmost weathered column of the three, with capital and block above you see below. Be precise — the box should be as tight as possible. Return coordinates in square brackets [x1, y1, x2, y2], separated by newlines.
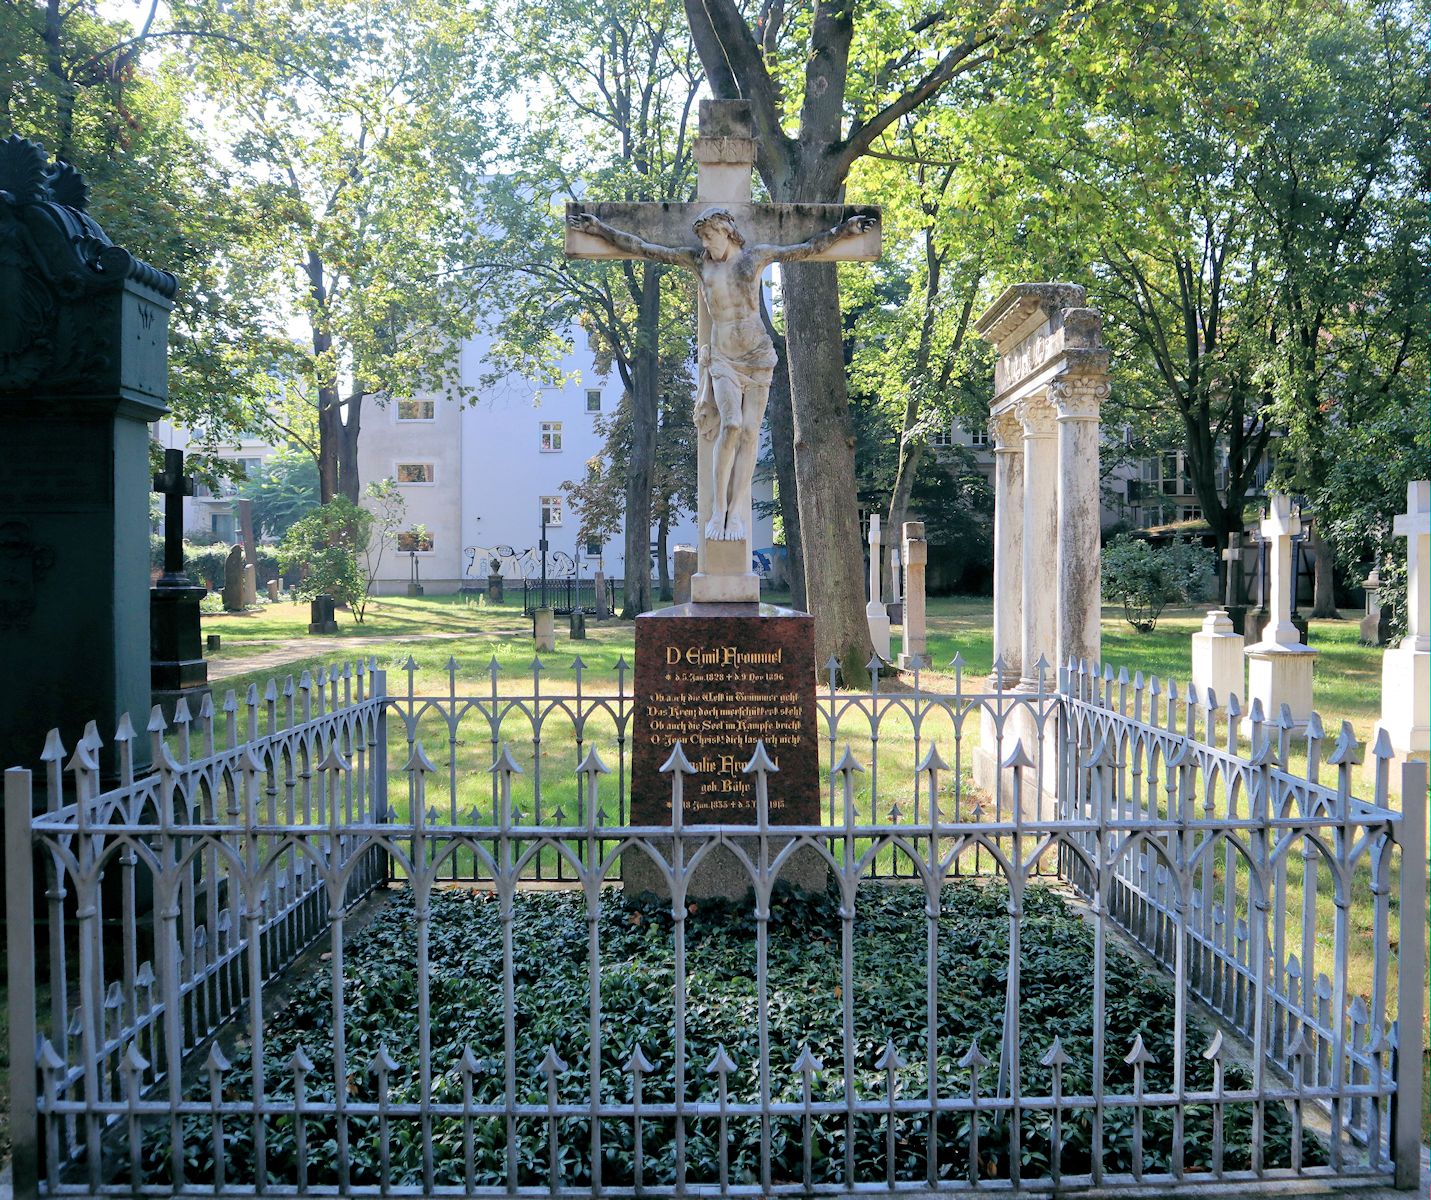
[1049, 328, 1109, 667]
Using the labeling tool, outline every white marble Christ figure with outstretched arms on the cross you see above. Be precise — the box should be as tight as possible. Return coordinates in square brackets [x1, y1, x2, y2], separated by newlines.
[568, 206, 876, 542]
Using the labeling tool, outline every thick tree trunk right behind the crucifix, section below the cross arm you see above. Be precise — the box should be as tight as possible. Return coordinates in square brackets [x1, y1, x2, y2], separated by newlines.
[783, 263, 874, 688]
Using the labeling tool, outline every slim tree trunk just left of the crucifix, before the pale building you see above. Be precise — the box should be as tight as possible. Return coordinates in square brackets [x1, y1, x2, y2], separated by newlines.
[621, 263, 661, 618]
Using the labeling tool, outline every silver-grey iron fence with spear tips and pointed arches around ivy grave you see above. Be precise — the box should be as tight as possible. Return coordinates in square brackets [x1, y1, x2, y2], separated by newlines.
[6, 662, 1427, 1196]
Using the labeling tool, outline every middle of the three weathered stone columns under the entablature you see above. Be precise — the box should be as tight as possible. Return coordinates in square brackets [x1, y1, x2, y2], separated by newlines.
[1015, 396, 1059, 691]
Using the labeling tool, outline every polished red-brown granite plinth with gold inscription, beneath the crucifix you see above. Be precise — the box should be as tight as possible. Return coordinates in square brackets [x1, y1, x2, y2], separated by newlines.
[622, 604, 826, 898]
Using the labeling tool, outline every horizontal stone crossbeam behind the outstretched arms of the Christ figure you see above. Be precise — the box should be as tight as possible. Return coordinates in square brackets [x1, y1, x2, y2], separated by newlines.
[567, 200, 880, 262]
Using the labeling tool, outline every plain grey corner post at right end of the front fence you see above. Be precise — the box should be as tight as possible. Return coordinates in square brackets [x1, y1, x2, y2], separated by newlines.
[1391, 762, 1427, 1190]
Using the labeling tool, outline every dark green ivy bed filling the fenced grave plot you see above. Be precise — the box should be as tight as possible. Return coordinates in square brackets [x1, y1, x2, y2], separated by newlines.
[145, 882, 1322, 1186]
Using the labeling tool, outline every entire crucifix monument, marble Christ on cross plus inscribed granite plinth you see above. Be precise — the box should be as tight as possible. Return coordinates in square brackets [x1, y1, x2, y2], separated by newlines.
[567, 100, 880, 895]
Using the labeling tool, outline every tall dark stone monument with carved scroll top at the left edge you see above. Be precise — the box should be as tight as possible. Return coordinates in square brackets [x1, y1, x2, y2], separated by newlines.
[0, 137, 179, 771]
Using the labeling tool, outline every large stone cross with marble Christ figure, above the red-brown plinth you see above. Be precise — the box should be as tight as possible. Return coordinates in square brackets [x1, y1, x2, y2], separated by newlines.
[567, 100, 880, 602]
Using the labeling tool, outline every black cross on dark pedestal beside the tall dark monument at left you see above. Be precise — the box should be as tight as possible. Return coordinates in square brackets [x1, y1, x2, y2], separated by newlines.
[149, 451, 209, 719]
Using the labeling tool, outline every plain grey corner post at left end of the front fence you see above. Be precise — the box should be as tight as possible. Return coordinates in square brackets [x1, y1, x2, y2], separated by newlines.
[4, 767, 39, 1200]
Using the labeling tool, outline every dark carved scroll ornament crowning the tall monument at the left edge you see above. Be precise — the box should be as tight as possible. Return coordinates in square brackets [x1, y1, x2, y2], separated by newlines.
[0, 136, 179, 392]
